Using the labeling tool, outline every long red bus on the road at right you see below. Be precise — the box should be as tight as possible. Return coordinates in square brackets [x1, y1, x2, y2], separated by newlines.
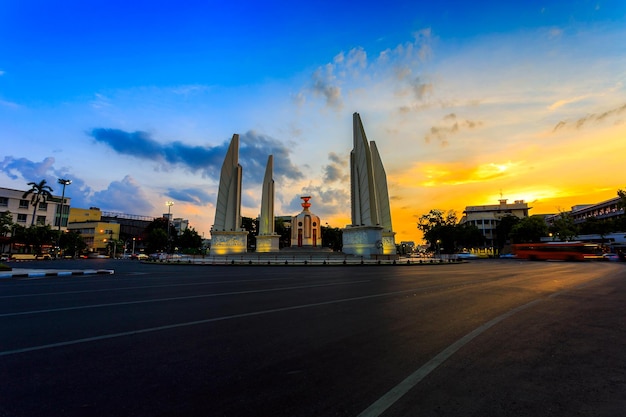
[513, 242, 602, 261]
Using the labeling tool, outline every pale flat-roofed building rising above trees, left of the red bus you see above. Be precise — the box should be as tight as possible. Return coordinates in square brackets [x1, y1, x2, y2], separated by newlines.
[459, 198, 532, 248]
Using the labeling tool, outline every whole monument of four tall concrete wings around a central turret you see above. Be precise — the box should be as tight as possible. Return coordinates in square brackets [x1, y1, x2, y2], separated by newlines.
[211, 113, 396, 258]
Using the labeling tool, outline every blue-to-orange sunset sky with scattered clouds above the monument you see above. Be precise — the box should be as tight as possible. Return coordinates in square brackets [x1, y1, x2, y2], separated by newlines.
[0, 0, 626, 243]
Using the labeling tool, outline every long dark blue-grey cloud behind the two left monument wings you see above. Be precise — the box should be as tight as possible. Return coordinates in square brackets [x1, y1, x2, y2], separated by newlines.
[90, 128, 303, 184]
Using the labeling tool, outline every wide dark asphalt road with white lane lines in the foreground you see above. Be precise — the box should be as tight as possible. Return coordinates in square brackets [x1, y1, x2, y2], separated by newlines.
[0, 260, 626, 417]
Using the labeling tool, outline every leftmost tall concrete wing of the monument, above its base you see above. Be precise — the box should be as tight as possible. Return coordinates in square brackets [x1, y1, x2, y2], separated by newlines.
[213, 134, 242, 231]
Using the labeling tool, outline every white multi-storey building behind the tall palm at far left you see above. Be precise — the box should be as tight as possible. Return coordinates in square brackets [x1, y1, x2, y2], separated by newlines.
[0, 188, 71, 230]
